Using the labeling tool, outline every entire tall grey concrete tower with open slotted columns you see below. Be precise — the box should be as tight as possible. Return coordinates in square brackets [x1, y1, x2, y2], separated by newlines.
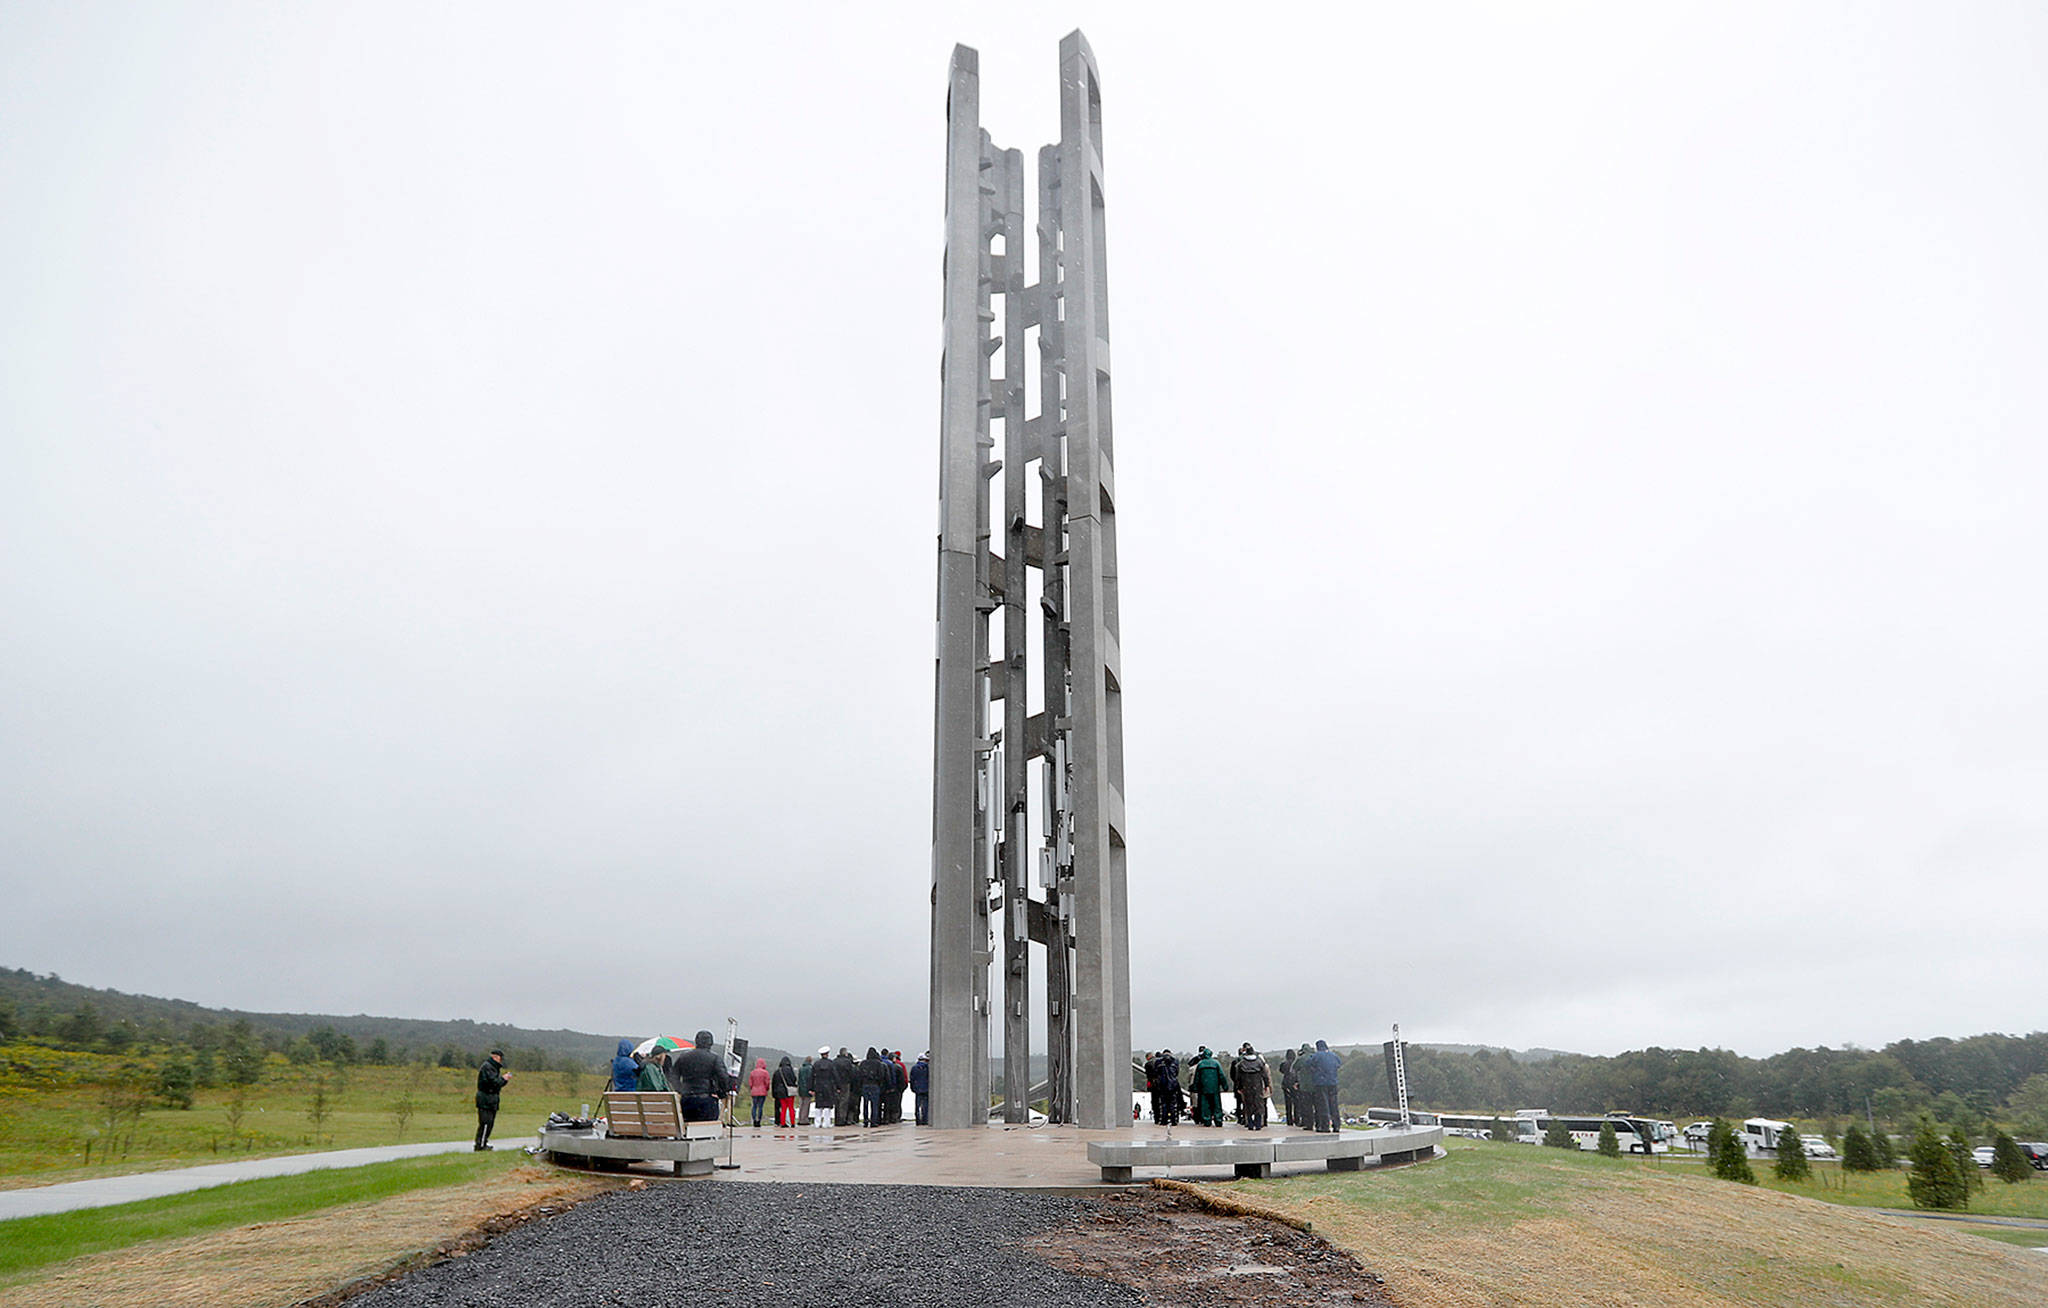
[932, 33, 1130, 1128]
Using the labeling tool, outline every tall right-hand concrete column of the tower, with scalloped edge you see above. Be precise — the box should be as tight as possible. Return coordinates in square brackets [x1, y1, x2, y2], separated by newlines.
[1057, 33, 1130, 1128]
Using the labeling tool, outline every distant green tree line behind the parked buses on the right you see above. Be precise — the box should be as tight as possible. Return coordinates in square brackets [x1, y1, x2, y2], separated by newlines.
[1341, 1032, 2048, 1140]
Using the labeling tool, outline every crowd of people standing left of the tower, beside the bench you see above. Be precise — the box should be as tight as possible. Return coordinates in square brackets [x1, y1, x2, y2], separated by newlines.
[610, 1032, 932, 1130]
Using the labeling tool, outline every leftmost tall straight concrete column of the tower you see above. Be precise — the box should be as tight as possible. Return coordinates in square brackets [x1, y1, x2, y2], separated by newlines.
[930, 45, 987, 1126]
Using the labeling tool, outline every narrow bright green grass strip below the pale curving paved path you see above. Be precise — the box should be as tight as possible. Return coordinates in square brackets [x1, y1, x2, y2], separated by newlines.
[0, 1150, 524, 1285]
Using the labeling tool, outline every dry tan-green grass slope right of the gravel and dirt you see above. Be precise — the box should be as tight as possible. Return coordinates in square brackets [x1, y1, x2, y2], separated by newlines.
[1229, 1140, 2048, 1308]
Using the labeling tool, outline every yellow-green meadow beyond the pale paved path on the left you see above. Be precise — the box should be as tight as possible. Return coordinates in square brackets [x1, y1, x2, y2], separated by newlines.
[0, 1046, 604, 1189]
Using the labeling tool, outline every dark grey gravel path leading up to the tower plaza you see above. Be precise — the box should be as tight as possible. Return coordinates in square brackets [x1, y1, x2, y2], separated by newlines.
[348, 1183, 1139, 1308]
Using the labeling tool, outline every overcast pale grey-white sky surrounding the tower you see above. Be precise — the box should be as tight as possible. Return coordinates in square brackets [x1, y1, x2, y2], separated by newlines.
[0, 0, 2048, 1054]
